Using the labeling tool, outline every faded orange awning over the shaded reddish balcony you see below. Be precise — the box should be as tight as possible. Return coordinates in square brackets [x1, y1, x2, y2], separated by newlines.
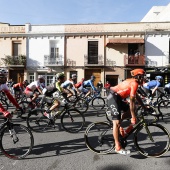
[108, 38, 144, 44]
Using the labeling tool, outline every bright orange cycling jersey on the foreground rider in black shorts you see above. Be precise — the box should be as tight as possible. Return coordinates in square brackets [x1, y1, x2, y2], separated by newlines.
[110, 79, 138, 99]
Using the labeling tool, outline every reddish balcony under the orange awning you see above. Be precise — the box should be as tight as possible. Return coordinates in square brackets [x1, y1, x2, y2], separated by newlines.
[124, 55, 145, 66]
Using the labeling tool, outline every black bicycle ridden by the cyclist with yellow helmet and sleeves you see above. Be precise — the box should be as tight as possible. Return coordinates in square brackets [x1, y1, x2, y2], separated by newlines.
[26, 99, 85, 133]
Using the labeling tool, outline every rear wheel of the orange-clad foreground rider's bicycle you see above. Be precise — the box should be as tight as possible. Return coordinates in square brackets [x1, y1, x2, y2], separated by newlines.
[84, 122, 114, 154]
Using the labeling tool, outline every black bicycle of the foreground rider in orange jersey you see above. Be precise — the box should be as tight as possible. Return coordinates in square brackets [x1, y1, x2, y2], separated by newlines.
[84, 113, 170, 157]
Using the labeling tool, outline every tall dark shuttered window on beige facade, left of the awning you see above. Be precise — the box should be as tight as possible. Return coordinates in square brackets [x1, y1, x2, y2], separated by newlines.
[88, 41, 98, 64]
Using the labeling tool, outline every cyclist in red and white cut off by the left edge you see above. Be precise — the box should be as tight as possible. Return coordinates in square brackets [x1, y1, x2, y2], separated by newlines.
[0, 69, 23, 118]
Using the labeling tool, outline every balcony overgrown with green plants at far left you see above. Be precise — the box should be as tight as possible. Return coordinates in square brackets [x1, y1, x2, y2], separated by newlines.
[1, 55, 26, 67]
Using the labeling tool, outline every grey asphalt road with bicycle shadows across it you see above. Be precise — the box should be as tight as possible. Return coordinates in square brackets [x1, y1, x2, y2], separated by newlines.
[0, 102, 170, 170]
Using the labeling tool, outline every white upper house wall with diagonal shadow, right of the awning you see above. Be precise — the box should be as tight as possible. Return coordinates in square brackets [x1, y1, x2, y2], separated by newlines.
[145, 35, 170, 67]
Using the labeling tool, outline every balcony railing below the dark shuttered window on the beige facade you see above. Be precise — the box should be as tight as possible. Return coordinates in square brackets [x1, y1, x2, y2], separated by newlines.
[84, 55, 104, 66]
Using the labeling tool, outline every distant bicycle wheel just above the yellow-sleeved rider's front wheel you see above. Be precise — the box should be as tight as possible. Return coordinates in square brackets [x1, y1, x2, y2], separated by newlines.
[75, 98, 89, 113]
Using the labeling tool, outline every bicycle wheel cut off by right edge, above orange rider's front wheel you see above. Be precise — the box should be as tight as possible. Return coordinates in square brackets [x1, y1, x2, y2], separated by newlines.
[158, 100, 170, 116]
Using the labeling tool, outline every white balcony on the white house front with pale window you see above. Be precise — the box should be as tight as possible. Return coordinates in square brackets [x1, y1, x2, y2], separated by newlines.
[44, 55, 64, 67]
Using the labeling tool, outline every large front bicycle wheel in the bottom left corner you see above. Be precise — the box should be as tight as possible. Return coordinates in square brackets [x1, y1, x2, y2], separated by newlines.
[0, 124, 34, 159]
